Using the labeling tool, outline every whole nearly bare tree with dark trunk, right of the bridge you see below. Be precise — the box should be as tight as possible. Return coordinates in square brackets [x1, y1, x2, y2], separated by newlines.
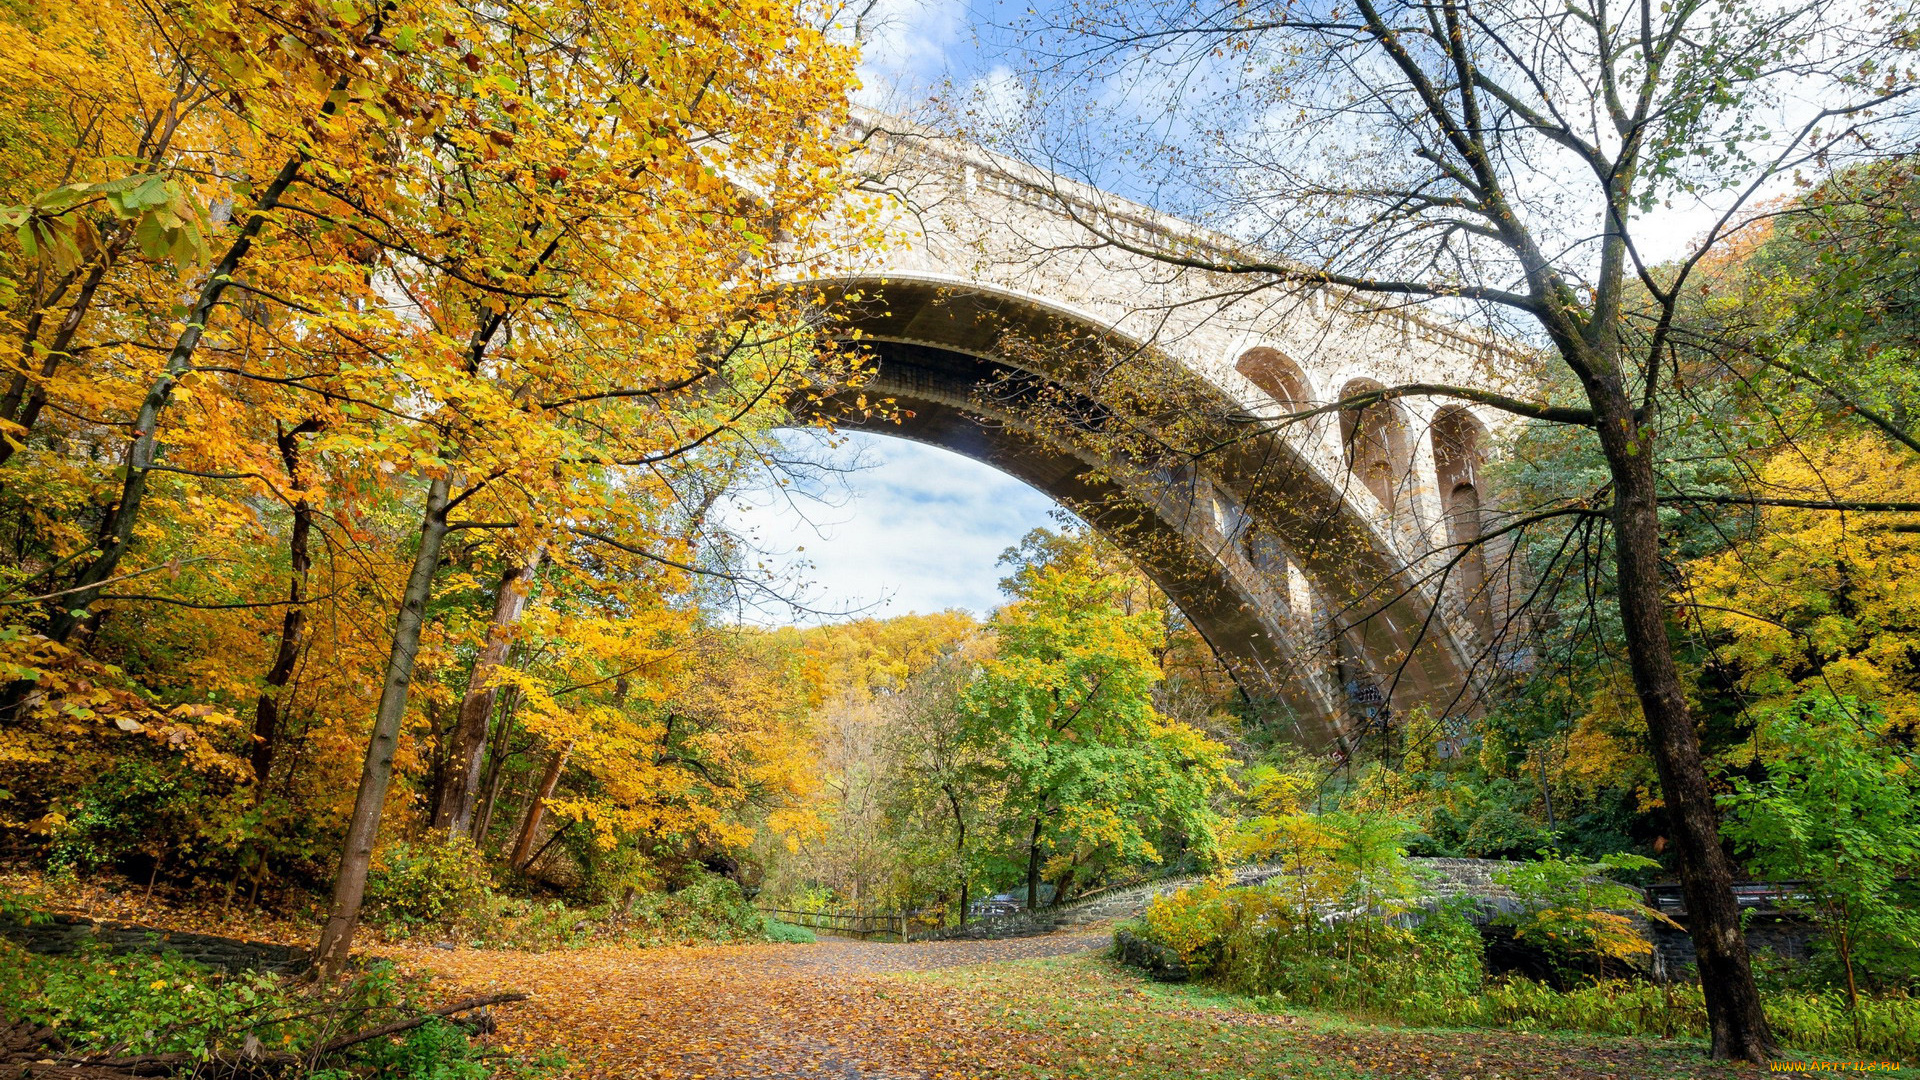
[990, 0, 1910, 1059]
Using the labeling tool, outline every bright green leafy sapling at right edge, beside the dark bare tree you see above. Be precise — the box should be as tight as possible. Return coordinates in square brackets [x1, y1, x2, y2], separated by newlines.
[1722, 694, 1920, 984]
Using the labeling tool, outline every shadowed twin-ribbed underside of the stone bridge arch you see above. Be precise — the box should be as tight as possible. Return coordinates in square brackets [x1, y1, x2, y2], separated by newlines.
[808, 281, 1478, 749]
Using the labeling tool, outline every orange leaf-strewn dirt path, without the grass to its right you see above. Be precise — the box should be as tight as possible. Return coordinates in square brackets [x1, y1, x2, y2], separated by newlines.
[382, 932, 1112, 1080]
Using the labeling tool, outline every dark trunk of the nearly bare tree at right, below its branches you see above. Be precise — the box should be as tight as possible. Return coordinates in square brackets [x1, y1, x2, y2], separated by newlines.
[1596, 403, 1774, 1061]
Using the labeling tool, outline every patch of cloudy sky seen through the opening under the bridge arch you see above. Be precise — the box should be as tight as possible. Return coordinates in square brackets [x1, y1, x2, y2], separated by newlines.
[726, 424, 1056, 619]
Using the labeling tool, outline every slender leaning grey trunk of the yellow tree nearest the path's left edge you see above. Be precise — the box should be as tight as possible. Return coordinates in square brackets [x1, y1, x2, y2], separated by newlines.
[315, 479, 451, 978]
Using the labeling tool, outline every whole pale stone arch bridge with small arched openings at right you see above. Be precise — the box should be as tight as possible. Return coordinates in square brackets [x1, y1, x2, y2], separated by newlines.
[791, 115, 1524, 753]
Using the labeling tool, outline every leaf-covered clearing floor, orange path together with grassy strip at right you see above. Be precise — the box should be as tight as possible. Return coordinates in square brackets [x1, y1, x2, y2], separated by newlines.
[390, 934, 1751, 1080]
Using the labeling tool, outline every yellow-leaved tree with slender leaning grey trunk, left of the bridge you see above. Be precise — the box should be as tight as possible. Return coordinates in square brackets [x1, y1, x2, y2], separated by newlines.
[301, 4, 864, 967]
